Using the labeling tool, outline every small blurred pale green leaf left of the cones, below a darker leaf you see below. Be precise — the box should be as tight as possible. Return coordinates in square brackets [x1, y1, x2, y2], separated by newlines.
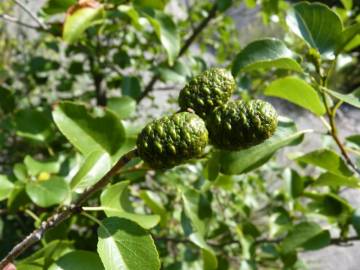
[107, 96, 136, 119]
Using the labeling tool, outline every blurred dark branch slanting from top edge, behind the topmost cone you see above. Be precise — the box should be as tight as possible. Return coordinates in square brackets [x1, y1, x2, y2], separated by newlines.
[137, 3, 218, 103]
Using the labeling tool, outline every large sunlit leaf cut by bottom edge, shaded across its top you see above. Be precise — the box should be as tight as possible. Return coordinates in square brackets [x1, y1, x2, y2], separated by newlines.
[98, 217, 160, 270]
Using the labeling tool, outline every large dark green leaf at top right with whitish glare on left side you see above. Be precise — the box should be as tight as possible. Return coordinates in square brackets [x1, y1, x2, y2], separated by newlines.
[286, 2, 343, 55]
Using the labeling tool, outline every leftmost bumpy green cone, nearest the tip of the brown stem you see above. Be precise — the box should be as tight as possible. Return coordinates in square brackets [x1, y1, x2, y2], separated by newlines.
[136, 112, 208, 169]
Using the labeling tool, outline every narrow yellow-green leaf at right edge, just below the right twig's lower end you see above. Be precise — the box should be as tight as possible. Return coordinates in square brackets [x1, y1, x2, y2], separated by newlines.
[312, 172, 360, 188]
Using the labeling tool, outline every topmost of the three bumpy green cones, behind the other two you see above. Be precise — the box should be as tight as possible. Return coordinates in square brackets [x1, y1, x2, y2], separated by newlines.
[179, 68, 236, 118]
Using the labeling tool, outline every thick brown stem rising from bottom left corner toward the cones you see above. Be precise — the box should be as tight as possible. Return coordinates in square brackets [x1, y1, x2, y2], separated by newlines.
[0, 149, 137, 269]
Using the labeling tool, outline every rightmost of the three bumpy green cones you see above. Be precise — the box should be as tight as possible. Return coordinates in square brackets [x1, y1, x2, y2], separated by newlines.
[206, 100, 278, 150]
